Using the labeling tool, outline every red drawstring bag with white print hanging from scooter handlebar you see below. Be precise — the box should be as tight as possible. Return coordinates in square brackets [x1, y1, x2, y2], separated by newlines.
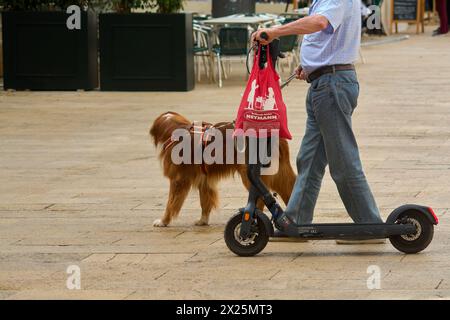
[235, 46, 292, 139]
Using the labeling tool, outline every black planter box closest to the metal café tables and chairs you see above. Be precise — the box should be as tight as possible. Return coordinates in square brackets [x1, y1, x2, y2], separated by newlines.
[100, 13, 195, 91]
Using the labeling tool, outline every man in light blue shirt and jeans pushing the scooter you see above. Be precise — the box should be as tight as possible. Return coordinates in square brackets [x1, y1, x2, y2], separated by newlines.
[253, 0, 382, 235]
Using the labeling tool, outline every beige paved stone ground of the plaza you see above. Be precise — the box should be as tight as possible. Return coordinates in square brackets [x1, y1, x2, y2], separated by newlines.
[0, 32, 450, 299]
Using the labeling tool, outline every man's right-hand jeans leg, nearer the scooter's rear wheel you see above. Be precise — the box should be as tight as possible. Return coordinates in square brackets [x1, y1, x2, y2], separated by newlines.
[312, 71, 382, 223]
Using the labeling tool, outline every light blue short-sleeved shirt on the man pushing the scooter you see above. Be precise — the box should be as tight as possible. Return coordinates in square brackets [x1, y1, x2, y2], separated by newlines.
[300, 0, 361, 74]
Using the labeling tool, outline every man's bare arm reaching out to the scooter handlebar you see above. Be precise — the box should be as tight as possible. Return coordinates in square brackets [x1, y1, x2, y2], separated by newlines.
[253, 14, 329, 45]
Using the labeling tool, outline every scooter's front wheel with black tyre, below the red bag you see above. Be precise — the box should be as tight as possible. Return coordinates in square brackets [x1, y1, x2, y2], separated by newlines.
[224, 212, 269, 257]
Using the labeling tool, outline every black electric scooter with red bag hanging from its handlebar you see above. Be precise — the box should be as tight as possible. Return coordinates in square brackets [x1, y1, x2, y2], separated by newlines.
[224, 34, 439, 256]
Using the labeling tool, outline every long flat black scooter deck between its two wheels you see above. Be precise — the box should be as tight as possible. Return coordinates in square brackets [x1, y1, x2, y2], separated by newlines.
[272, 223, 416, 240]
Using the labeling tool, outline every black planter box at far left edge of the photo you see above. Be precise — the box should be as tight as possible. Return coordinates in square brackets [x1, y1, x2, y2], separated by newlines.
[2, 11, 98, 90]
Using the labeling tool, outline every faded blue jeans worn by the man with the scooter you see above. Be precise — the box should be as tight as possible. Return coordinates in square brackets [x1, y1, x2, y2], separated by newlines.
[286, 70, 382, 224]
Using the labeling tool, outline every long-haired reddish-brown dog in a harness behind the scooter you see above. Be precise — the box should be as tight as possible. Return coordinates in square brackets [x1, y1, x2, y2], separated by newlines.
[150, 112, 295, 227]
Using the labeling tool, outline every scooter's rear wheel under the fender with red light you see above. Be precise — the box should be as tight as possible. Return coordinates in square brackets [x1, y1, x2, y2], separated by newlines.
[389, 210, 434, 253]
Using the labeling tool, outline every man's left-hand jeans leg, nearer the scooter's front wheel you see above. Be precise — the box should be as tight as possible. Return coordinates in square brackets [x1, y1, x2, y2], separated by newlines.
[286, 87, 327, 224]
